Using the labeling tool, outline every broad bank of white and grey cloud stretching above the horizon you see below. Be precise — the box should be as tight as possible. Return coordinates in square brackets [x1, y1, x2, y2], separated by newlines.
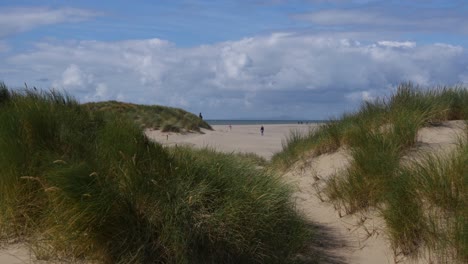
[0, 33, 468, 118]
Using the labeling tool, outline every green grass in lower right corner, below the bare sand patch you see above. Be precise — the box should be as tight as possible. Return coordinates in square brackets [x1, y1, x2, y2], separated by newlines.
[390, 143, 468, 263]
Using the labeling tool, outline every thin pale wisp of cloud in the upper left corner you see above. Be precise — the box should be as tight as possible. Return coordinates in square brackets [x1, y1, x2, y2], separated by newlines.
[0, 7, 99, 38]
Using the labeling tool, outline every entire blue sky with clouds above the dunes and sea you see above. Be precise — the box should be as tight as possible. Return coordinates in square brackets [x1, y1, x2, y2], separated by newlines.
[0, 0, 468, 120]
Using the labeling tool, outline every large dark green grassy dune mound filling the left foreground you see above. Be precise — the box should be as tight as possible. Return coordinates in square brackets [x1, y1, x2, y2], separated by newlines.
[0, 85, 309, 263]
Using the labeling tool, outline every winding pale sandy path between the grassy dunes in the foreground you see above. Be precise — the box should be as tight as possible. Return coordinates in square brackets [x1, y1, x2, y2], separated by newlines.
[284, 149, 394, 264]
